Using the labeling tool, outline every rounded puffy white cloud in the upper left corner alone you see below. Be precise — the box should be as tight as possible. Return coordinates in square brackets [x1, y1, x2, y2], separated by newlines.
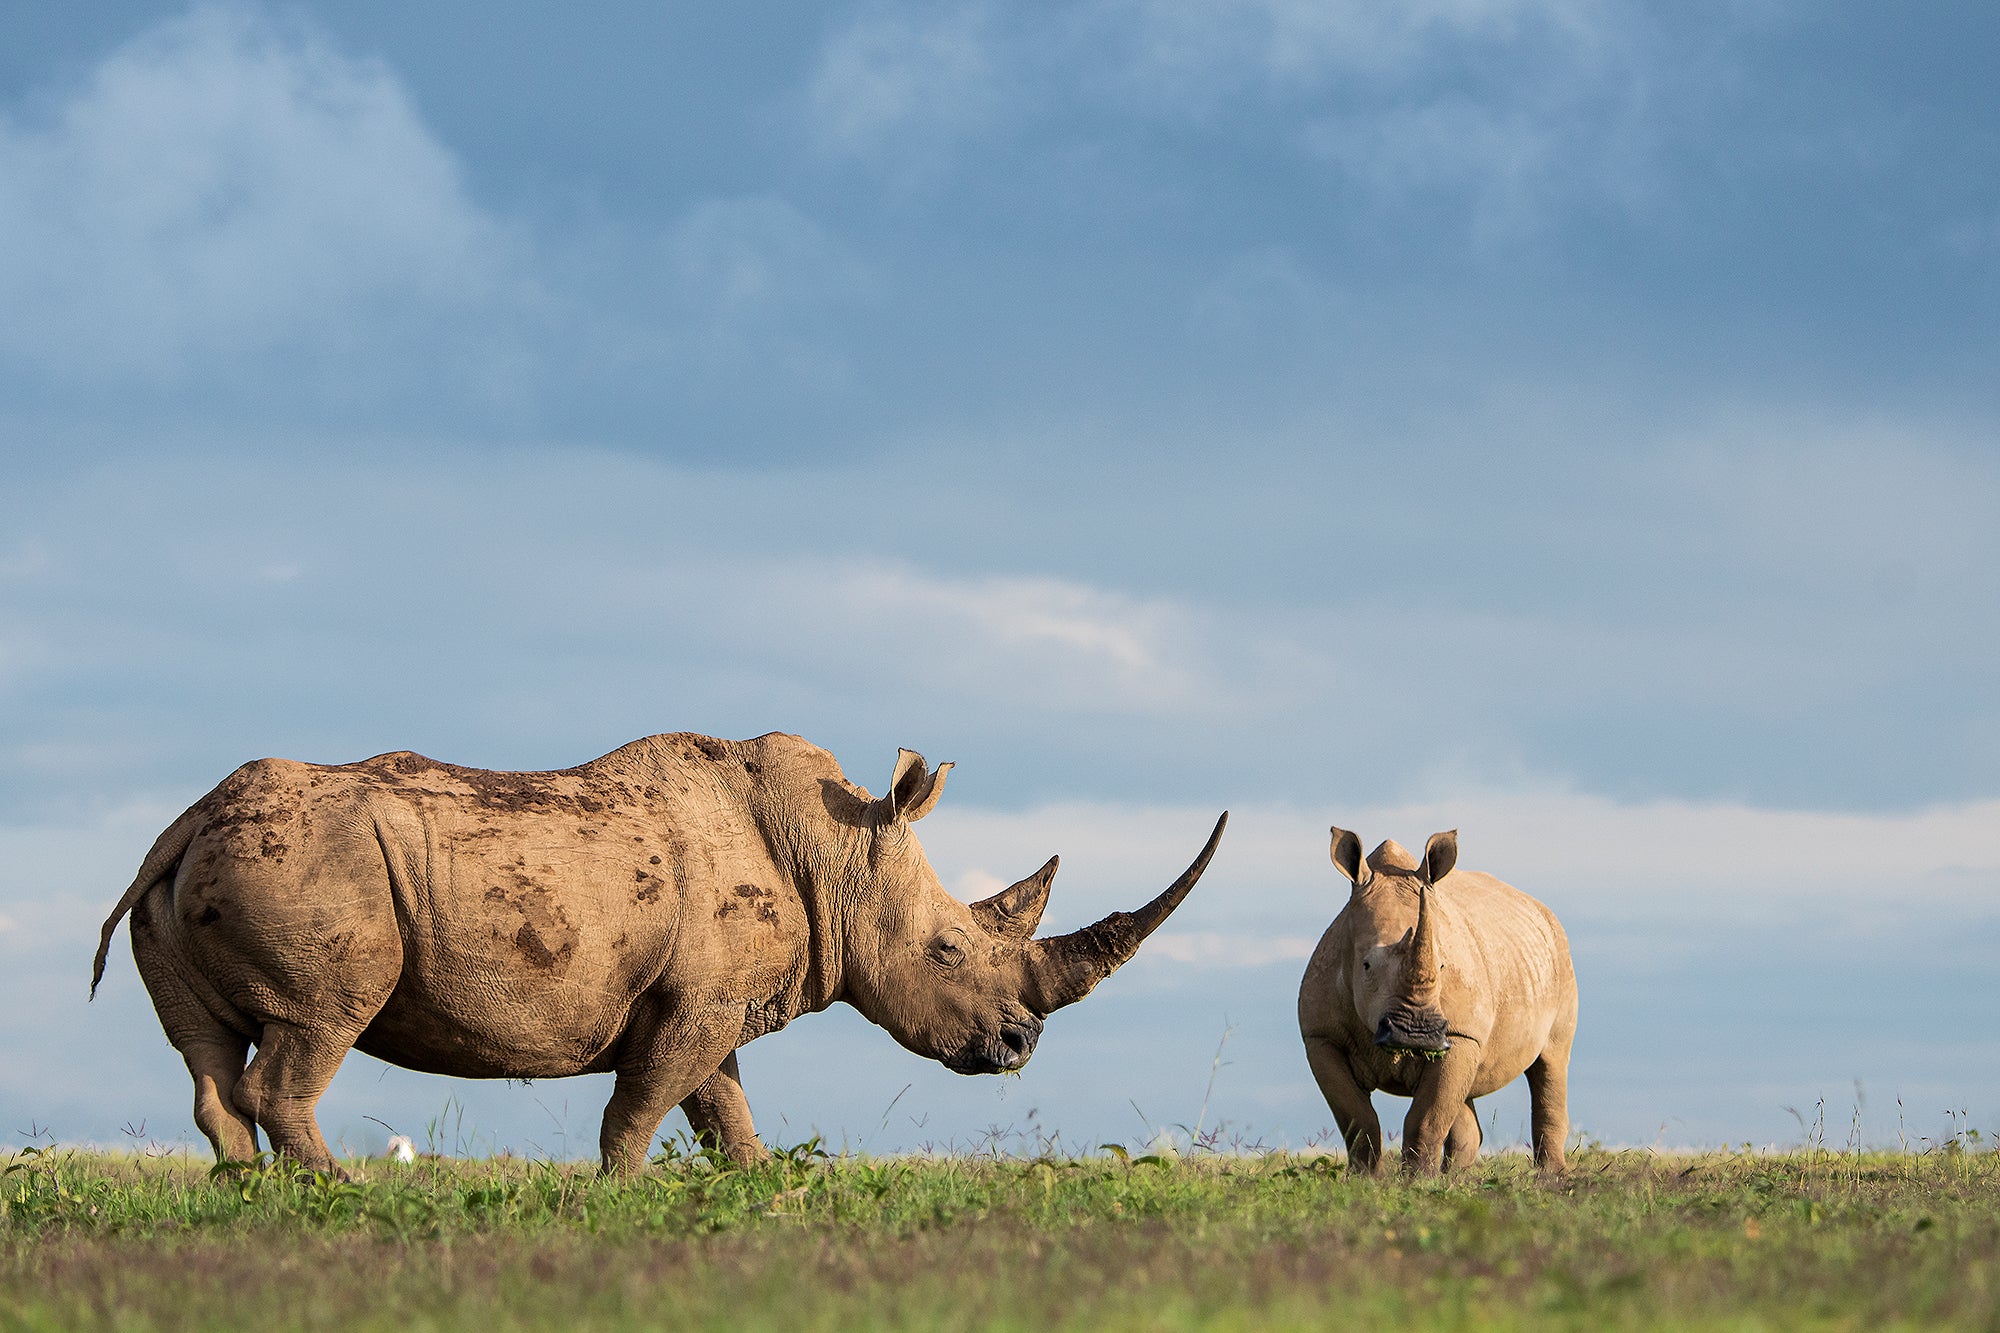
[0, 4, 518, 384]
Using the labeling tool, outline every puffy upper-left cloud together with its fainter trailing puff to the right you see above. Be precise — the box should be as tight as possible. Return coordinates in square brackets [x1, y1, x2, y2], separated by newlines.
[0, 2, 872, 422]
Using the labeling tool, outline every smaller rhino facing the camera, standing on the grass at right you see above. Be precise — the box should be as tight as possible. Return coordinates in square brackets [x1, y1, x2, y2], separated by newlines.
[1298, 829, 1576, 1175]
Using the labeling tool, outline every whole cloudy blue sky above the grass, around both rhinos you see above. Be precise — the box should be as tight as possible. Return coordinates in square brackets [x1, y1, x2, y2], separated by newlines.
[0, 0, 2000, 1151]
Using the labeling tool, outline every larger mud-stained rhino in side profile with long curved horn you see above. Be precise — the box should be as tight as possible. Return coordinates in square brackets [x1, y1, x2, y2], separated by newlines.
[90, 735, 1226, 1171]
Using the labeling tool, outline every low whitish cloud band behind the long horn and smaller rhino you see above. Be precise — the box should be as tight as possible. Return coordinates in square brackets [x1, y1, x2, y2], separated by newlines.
[922, 789, 2000, 944]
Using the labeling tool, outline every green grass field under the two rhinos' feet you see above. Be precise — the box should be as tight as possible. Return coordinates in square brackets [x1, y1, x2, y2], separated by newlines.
[0, 1147, 2000, 1333]
